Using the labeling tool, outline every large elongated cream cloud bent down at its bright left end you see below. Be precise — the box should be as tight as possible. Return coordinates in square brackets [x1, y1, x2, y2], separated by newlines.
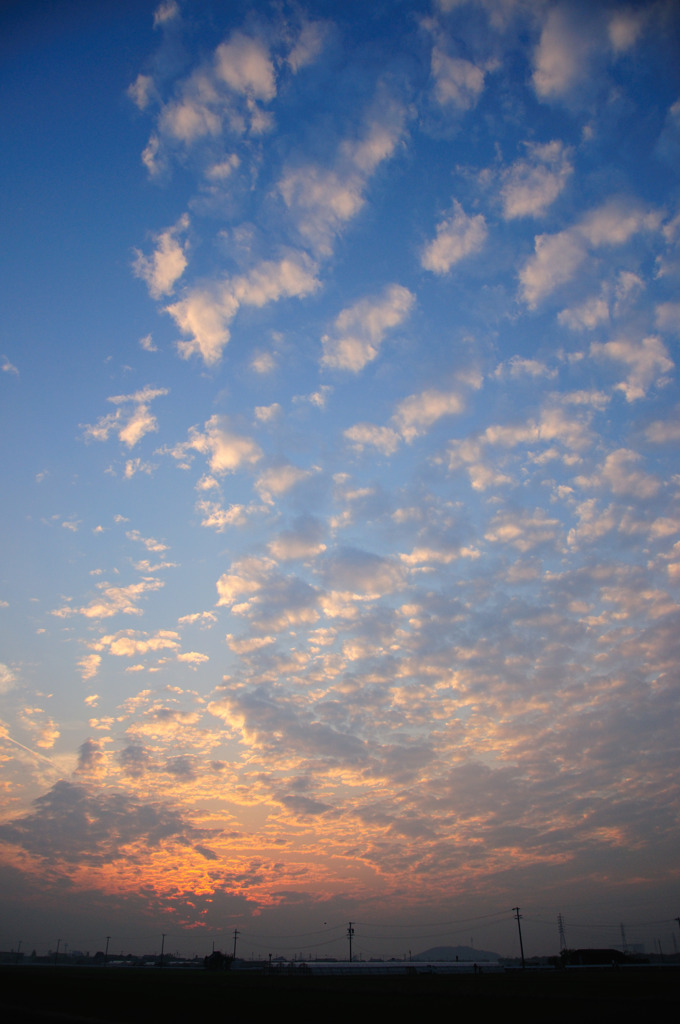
[166, 254, 318, 366]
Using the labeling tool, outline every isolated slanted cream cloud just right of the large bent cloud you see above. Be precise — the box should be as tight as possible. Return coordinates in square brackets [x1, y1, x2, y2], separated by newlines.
[322, 285, 415, 373]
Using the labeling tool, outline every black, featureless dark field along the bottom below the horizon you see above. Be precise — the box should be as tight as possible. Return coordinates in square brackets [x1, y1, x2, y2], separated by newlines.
[0, 967, 680, 1024]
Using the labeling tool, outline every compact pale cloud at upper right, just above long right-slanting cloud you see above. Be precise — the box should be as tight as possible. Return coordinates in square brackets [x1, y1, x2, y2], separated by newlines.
[501, 139, 573, 220]
